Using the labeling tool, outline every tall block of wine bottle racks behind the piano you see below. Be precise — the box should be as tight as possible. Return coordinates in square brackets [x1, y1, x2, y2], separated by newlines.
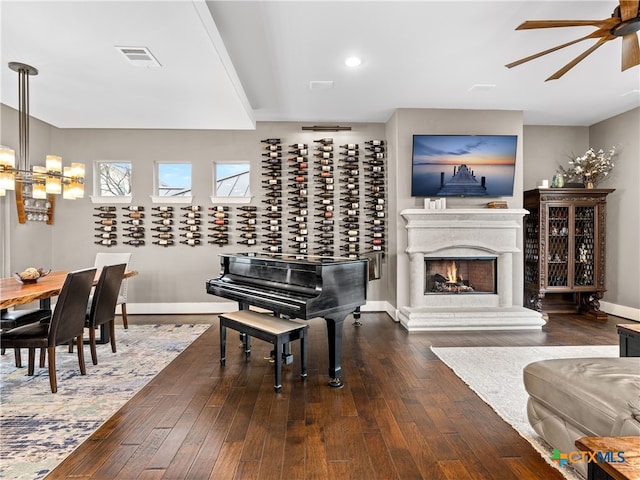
[255, 138, 386, 257]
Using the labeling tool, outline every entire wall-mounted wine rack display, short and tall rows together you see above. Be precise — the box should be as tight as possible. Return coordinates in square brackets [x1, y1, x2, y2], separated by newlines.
[94, 138, 386, 258]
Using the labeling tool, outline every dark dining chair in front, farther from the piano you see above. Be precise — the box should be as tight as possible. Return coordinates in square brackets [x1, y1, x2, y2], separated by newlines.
[0, 268, 96, 393]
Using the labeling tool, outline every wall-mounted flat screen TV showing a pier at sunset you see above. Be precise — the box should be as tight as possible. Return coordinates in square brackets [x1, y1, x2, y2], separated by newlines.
[411, 135, 518, 197]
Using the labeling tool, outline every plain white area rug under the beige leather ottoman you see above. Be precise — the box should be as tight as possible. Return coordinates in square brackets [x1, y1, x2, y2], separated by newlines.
[431, 345, 619, 480]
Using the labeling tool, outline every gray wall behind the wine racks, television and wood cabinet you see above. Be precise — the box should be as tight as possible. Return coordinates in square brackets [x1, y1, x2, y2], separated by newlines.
[0, 105, 640, 318]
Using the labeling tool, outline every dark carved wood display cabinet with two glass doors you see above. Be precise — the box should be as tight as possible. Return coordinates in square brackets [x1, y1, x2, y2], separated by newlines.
[524, 188, 614, 320]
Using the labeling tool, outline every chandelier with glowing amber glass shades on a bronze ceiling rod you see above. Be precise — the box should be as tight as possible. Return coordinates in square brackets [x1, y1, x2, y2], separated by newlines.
[0, 62, 84, 200]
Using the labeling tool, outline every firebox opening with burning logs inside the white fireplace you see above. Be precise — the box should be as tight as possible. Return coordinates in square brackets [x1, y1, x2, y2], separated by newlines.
[424, 257, 498, 295]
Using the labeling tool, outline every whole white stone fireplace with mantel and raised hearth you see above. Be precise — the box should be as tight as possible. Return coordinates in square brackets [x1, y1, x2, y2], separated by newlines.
[398, 208, 545, 331]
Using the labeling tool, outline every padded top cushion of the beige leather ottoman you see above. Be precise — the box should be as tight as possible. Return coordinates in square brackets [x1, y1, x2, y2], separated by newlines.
[523, 357, 640, 436]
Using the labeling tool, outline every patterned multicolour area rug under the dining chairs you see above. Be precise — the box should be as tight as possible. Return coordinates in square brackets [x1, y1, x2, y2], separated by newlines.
[0, 324, 209, 480]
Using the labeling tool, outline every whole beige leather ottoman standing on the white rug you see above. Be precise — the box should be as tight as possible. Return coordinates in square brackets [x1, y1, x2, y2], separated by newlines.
[523, 357, 640, 477]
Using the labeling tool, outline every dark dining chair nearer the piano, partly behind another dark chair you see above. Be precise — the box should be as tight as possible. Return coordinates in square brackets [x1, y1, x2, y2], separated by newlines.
[85, 263, 127, 365]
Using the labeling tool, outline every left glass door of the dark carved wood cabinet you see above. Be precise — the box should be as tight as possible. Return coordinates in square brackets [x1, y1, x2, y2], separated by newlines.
[546, 206, 570, 287]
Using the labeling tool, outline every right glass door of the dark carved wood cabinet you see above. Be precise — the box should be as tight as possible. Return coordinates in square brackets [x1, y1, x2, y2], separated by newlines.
[573, 206, 595, 287]
